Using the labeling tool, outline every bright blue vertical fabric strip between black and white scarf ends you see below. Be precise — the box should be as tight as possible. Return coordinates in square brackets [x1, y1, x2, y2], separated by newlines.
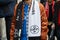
[21, 4, 28, 40]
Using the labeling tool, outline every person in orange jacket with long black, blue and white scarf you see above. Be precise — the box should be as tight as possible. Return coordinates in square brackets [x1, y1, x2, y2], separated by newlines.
[10, 0, 48, 40]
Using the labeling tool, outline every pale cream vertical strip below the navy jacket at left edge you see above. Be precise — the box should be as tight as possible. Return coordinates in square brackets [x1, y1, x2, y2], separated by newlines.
[0, 18, 7, 40]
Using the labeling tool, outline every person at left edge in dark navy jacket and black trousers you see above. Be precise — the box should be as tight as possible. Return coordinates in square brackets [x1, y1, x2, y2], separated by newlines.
[0, 0, 16, 40]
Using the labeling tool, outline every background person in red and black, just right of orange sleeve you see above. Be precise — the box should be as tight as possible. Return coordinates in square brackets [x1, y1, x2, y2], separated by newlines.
[45, 0, 55, 40]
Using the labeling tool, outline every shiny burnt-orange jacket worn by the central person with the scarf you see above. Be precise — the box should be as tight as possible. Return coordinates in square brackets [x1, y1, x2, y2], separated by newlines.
[10, 3, 48, 40]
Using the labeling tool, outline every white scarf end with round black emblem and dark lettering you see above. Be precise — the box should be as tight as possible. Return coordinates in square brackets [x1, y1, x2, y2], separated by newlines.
[28, 0, 41, 37]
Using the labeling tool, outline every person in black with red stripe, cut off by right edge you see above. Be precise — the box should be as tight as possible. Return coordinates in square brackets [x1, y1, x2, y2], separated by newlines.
[53, 0, 60, 40]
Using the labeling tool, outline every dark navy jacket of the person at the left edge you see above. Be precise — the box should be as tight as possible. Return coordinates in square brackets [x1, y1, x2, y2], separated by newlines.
[0, 0, 16, 18]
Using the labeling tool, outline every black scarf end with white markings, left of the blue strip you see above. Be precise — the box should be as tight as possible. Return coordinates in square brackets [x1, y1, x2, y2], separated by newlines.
[14, 3, 22, 40]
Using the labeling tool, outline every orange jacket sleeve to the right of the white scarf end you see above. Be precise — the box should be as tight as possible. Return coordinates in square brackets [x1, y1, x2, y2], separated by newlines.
[39, 3, 48, 40]
